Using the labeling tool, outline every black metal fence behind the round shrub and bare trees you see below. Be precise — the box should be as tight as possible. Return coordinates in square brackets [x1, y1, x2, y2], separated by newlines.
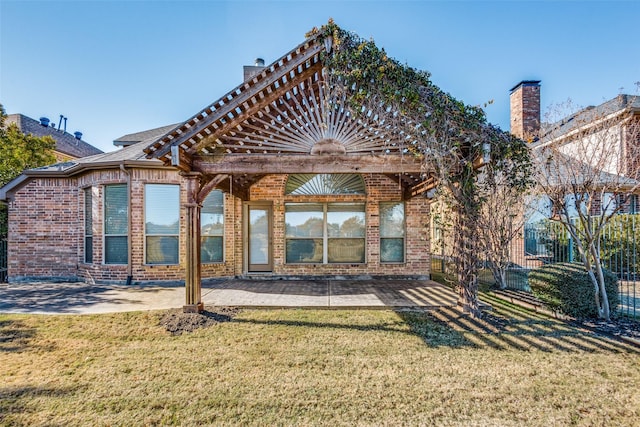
[431, 214, 640, 316]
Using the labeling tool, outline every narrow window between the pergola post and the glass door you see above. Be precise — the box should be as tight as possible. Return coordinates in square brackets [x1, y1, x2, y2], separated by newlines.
[205, 190, 224, 263]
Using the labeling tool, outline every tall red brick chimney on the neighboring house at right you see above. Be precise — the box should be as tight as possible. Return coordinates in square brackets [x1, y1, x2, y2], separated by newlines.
[510, 80, 540, 142]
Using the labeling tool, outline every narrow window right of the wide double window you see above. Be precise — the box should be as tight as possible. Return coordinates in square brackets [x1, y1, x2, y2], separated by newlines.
[380, 202, 404, 262]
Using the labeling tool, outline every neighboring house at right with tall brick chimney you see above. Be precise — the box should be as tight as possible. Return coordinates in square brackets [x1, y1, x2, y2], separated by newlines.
[511, 81, 640, 267]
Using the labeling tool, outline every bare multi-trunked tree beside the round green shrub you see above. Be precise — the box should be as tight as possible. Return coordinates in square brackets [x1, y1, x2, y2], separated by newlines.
[534, 95, 640, 319]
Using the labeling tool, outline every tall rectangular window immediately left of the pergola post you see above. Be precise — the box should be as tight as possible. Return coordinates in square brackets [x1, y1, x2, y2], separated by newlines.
[144, 184, 180, 264]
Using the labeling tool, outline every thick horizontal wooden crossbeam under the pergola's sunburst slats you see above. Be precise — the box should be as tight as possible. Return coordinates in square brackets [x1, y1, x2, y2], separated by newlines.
[192, 153, 422, 175]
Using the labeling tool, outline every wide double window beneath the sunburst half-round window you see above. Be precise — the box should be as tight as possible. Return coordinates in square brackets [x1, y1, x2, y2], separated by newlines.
[285, 203, 366, 264]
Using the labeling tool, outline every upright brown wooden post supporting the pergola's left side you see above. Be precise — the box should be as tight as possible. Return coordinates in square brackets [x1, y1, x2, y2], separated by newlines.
[182, 172, 204, 313]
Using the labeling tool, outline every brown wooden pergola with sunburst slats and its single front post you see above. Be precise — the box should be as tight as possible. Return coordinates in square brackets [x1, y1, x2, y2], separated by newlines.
[145, 36, 433, 311]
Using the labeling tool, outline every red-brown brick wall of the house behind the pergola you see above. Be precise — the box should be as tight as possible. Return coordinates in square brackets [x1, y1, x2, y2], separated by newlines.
[8, 169, 430, 283]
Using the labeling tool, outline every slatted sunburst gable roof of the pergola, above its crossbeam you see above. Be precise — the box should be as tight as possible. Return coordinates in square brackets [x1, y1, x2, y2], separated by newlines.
[146, 30, 418, 164]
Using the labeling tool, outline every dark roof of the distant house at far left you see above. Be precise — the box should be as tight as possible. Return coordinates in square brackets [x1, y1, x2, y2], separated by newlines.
[5, 114, 102, 158]
